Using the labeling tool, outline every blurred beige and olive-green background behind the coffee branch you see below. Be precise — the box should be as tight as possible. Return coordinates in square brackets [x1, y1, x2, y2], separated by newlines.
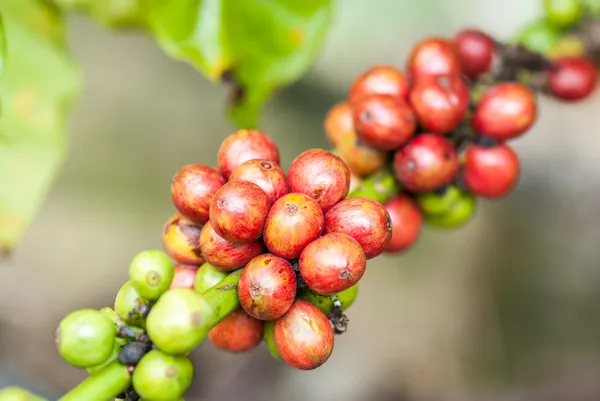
[0, 0, 600, 401]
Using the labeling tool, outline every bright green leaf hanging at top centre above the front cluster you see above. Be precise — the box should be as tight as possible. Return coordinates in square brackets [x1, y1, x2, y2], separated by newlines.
[143, 0, 333, 128]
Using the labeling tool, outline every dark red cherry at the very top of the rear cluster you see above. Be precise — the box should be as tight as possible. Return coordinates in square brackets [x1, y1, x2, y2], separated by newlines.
[454, 29, 495, 80]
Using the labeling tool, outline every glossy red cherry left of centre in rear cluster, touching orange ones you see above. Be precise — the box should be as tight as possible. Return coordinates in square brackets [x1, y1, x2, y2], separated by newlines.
[353, 95, 417, 150]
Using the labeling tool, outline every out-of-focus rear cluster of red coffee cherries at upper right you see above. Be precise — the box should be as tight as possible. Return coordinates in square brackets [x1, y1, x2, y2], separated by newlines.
[324, 21, 597, 253]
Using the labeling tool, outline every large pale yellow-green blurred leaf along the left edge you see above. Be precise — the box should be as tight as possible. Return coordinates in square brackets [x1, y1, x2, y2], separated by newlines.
[0, 0, 81, 250]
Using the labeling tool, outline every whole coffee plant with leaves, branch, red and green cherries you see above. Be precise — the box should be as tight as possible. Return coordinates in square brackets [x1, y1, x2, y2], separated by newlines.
[0, 0, 600, 401]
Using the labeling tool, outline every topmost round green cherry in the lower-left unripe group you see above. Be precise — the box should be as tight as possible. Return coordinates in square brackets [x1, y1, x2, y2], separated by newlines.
[129, 249, 175, 301]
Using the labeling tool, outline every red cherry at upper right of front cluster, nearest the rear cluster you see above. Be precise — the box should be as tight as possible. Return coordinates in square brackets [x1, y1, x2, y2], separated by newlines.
[288, 149, 350, 212]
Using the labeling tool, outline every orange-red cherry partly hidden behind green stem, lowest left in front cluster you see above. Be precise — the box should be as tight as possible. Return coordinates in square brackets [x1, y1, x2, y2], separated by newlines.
[207, 309, 264, 352]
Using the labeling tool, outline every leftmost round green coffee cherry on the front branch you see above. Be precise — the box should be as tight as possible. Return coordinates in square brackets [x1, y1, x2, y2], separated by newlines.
[56, 309, 117, 368]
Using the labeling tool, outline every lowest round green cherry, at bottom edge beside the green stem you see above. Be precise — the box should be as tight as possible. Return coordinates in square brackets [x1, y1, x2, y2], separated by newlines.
[132, 349, 194, 401]
